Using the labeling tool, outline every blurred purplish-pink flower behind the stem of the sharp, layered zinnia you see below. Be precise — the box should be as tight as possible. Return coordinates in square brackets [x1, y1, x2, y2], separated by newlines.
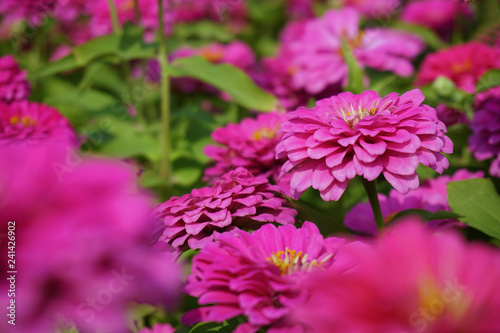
[344, 169, 483, 235]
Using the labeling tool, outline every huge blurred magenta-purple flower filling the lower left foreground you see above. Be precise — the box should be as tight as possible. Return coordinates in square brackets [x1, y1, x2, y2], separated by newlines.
[0, 143, 181, 333]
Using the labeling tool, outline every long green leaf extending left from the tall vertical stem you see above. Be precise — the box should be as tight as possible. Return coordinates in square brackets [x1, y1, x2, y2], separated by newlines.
[33, 25, 156, 78]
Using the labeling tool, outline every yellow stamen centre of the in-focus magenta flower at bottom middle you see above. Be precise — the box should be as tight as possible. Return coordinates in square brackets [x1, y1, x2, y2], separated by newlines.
[266, 248, 332, 276]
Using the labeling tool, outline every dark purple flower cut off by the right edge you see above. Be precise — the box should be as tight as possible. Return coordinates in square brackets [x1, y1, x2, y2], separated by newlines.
[469, 87, 500, 177]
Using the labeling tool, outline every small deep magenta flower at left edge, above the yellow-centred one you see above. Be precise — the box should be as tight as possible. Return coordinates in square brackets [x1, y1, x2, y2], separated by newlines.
[0, 54, 31, 103]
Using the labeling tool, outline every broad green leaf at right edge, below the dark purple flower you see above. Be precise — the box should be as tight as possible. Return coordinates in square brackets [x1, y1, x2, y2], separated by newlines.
[448, 178, 500, 239]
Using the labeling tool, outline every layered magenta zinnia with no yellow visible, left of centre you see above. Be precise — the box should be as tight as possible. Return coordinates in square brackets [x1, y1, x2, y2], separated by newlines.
[154, 168, 297, 250]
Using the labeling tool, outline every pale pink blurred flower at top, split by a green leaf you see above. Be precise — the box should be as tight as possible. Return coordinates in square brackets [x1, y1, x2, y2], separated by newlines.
[282, 8, 423, 94]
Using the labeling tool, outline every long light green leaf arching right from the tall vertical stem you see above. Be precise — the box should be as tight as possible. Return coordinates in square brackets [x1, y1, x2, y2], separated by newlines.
[169, 57, 278, 111]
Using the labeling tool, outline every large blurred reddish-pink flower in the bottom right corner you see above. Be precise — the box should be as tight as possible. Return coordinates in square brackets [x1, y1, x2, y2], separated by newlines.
[293, 221, 500, 333]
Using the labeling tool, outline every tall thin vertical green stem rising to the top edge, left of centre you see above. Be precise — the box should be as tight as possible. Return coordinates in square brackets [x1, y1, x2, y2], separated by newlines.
[158, 0, 171, 185]
